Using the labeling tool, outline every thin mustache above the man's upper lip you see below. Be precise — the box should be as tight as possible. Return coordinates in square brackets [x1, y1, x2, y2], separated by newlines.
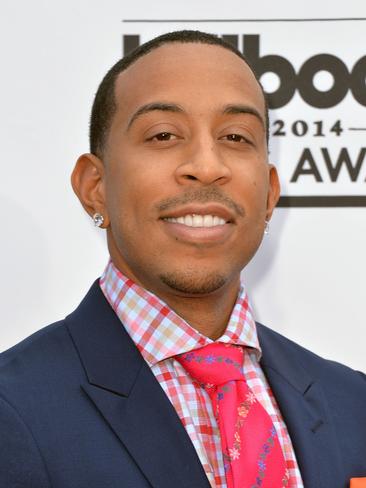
[156, 187, 245, 217]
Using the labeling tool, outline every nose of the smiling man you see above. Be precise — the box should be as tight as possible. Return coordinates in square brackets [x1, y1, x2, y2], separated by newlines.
[176, 135, 231, 185]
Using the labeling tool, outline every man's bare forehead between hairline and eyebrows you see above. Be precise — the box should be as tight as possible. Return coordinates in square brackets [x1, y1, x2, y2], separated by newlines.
[115, 42, 265, 118]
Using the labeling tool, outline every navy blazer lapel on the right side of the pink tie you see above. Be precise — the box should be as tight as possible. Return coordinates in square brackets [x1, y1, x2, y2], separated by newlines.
[258, 324, 343, 488]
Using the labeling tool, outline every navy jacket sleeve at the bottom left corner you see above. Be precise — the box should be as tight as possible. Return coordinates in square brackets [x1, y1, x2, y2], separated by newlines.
[0, 397, 51, 488]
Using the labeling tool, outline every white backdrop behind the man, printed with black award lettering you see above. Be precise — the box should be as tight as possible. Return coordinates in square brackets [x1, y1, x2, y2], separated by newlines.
[0, 0, 366, 370]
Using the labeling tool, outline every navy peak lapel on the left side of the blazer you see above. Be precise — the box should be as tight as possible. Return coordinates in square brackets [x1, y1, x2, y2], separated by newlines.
[67, 282, 210, 488]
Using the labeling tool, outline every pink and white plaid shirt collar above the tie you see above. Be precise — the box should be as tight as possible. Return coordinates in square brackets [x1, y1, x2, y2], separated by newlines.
[100, 261, 261, 366]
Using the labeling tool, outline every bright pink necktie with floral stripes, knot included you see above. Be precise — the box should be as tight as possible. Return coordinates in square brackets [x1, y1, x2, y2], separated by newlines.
[176, 342, 288, 488]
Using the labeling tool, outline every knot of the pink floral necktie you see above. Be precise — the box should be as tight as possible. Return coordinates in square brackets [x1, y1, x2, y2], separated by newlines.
[176, 342, 244, 386]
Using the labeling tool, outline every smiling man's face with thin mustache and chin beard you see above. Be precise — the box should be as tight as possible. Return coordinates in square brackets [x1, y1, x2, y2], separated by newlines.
[104, 43, 277, 297]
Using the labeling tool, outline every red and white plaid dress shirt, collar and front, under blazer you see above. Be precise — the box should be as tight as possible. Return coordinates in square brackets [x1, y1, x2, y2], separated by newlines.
[100, 261, 303, 488]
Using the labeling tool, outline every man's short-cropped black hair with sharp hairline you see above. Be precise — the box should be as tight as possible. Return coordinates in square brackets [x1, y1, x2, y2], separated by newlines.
[89, 30, 269, 158]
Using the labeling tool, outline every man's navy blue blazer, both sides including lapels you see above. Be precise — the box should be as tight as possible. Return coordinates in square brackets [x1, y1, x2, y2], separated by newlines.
[0, 282, 366, 488]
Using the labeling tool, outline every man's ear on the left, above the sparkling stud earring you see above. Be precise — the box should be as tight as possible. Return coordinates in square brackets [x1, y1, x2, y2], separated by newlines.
[71, 153, 109, 227]
